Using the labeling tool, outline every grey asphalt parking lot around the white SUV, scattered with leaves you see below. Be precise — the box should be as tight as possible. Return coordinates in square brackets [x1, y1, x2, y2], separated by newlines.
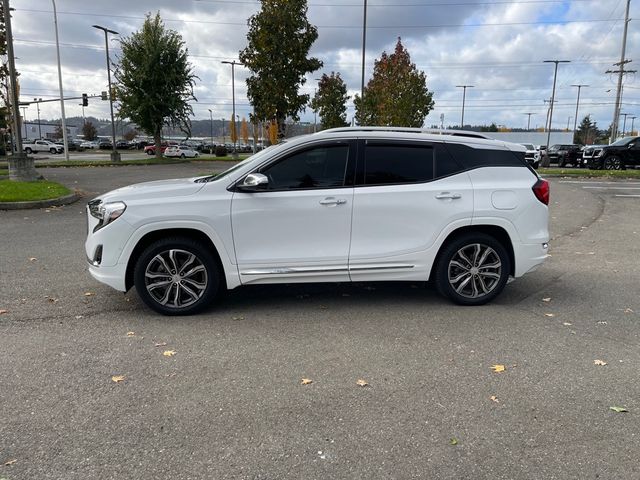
[0, 163, 640, 480]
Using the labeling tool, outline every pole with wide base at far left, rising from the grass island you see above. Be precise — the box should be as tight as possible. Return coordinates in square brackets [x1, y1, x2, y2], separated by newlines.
[2, 0, 42, 181]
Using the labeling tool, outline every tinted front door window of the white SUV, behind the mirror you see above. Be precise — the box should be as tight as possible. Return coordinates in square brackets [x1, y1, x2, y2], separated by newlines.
[261, 145, 349, 190]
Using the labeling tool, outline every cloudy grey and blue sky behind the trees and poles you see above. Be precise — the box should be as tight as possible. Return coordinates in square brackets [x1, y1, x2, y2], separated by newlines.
[11, 0, 640, 132]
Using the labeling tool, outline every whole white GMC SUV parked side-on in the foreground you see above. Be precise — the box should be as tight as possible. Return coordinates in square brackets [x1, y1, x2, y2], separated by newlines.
[85, 127, 549, 315]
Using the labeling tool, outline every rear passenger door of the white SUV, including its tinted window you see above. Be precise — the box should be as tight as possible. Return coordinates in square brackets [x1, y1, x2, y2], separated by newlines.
[349, 140, 473, 281]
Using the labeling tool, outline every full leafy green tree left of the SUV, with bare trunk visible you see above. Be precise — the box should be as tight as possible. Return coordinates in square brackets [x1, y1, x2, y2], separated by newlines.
[115, 13, 197, 157]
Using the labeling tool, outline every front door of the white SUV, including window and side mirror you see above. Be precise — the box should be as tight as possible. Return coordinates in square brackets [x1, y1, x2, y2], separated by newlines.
[231, 141, 355, 283]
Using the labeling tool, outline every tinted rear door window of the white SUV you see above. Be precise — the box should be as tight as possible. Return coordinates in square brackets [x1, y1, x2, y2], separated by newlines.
[364, 144, 433, 185]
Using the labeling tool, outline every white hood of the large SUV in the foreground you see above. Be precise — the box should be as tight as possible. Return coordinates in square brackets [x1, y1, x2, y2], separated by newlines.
[98, 177, 206, 202]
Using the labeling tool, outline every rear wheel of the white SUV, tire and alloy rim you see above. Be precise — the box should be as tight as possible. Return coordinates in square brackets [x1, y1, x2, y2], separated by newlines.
[435, 233, 511, 306]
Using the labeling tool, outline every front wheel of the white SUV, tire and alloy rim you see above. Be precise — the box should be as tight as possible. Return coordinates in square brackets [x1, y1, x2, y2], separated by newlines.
[133, 237, 221, 315]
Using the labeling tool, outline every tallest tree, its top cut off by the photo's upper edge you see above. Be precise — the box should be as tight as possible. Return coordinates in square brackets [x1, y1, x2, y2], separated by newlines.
[240, 0, 322, 138]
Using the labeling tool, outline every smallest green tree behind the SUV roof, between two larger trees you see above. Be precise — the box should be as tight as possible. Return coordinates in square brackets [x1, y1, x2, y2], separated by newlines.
[311, 72, 349, 128]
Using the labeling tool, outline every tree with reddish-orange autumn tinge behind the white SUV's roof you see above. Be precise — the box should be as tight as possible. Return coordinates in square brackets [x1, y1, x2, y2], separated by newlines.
[354, 38, 434, 127]
